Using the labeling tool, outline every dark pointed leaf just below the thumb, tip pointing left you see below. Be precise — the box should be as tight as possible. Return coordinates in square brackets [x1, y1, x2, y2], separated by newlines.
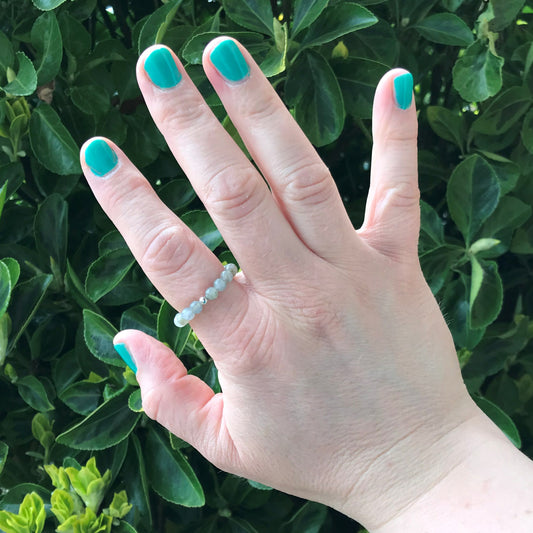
[56, 391, 141, 450]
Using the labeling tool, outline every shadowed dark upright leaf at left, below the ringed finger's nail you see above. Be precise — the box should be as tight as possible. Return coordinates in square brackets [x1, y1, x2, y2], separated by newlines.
[34, 193, 68, 272]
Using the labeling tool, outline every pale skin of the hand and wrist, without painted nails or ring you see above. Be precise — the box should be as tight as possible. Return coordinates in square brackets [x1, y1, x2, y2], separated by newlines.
[81, 40, 533, 533]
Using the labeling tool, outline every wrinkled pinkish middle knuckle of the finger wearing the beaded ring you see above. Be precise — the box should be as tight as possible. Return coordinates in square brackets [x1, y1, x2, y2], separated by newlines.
[139, 226, 194, 276]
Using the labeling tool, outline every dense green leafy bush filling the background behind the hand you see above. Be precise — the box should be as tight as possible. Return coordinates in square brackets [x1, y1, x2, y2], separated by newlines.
[0, 0, 533, 533]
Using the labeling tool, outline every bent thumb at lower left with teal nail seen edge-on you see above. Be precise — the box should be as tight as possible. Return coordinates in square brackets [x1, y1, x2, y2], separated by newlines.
[113, 330, 238, 471]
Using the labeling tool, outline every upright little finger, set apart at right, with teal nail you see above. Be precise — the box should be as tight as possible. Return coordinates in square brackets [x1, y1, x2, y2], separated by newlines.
[359, 69, 420, 260]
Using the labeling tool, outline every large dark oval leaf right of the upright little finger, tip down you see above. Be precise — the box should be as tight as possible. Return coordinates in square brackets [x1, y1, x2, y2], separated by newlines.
[446, 155, 500, 246]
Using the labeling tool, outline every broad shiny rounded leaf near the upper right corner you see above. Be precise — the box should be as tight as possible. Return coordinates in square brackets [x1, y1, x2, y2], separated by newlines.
[453, 40, 505, 102]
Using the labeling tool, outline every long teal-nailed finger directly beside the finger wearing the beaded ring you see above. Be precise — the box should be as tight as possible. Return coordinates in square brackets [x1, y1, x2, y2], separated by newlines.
[137, 46, 305, 280]
